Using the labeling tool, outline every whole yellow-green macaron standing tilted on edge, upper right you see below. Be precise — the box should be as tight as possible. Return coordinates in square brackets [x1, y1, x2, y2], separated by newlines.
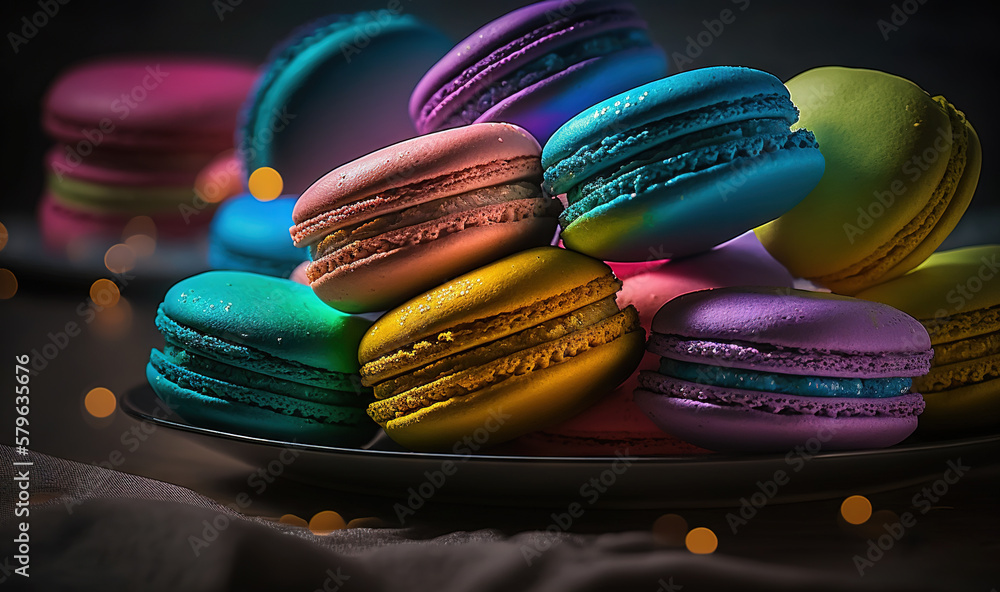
[757, 66, 982, 294]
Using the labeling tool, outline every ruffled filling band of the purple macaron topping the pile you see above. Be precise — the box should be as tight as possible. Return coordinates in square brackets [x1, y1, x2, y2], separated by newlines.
[416, 8, 653, 132]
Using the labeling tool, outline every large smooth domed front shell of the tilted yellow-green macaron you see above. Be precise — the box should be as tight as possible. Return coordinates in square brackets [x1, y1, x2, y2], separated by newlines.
[757, 67, 968, 284]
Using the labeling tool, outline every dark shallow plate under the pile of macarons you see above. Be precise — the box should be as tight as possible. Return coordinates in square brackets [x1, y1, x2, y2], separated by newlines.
[121, 384, 1000, 509]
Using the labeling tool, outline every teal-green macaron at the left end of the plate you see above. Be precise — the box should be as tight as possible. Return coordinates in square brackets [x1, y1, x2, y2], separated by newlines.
[146, 271, 378, 446]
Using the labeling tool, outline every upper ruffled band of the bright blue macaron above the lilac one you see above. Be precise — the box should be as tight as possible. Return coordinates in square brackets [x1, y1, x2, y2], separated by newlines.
[542, 91, 798, 195]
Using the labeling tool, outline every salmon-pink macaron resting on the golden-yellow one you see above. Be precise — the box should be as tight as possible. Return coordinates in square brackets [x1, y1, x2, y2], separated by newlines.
[291, 123, 562, 312]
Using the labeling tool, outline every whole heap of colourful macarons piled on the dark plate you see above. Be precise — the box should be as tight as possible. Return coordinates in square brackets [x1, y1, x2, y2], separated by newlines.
[131, 0, 1000, 455]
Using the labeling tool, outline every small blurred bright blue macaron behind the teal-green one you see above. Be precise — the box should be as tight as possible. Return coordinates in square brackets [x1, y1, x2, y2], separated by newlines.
[208, 193, 309, 278]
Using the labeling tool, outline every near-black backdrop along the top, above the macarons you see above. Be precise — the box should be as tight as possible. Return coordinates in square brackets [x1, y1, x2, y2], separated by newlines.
[0, 0, 1000, 247]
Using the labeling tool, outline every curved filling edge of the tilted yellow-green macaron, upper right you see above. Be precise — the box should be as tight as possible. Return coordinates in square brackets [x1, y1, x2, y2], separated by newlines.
[809, 96, 969, 294]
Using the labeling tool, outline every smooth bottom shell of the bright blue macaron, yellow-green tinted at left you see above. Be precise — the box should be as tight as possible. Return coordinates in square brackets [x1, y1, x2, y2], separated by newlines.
[561, 143, 824, 261]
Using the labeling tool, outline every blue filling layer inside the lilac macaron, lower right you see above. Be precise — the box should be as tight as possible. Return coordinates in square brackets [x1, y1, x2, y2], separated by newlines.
[660, 358, 913, 398]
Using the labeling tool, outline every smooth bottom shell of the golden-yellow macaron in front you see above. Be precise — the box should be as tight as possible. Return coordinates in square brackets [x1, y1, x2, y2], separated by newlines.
[385, 331, 644, 453]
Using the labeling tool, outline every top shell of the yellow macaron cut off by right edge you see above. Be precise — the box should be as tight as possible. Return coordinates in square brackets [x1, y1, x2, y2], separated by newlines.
[857, 245, 1000, 324]
